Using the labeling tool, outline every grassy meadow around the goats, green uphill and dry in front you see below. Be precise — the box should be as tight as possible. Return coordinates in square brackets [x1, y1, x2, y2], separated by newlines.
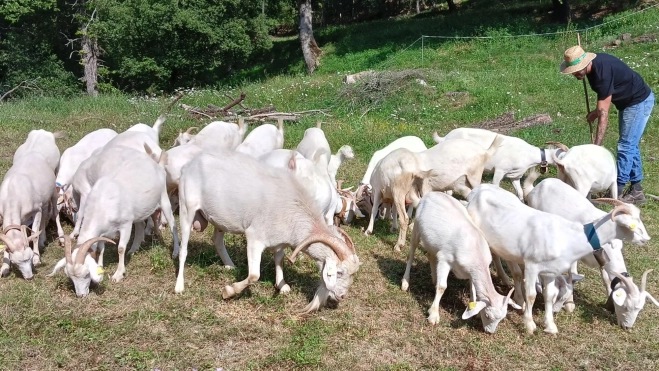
[0, 1, 659, 370]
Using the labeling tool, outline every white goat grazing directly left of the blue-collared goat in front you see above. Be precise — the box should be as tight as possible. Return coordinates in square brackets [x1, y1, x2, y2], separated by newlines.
[401, 192, 522, 334]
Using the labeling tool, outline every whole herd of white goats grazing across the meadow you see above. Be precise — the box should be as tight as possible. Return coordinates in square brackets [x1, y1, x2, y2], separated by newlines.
[0, 116, 659, 333]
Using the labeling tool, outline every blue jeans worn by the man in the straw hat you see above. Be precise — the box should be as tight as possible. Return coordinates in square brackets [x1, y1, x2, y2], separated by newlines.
[618, 92, 654, 186]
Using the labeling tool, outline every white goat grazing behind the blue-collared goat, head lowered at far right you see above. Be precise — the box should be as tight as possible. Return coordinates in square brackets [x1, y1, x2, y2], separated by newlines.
[524, 172, 654, 328]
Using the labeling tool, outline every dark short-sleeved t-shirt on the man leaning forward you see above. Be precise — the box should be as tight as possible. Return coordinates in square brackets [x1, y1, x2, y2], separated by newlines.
[586, 53, 650, 110]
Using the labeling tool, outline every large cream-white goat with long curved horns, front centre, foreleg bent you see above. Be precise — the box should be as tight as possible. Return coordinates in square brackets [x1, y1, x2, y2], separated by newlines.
[174, 152, 361, 312]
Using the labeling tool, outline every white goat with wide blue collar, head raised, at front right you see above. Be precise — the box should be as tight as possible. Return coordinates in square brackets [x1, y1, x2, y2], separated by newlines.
[467, 184, 650, 334]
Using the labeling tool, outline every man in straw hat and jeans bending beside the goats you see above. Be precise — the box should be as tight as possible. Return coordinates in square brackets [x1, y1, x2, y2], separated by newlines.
[560, 46, 654, 204]
